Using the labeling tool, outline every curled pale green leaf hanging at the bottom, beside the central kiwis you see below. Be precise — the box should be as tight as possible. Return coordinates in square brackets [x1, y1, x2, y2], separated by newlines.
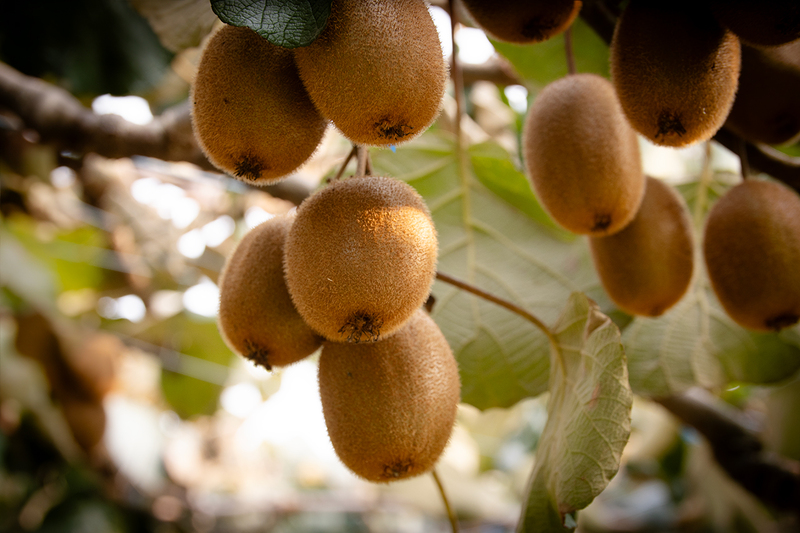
[518, 293, 633, 532]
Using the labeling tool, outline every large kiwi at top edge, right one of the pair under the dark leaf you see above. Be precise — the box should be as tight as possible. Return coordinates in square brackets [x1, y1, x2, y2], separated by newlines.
[294, 0, 447, 146]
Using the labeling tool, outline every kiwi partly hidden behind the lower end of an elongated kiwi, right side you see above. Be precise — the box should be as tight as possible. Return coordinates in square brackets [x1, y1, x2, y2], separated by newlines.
[589, 177, 694, 316]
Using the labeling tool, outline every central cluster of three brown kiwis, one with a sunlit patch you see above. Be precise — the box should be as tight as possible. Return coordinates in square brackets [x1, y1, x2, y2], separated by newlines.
[219, 176, 460, 482]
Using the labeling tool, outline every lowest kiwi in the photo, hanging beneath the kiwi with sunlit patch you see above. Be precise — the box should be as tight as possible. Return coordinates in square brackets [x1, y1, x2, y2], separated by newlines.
[319, 310, 461, 482]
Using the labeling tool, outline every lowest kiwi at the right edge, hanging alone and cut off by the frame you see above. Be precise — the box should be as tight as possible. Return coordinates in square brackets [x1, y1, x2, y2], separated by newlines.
[703, 179, 800, 331]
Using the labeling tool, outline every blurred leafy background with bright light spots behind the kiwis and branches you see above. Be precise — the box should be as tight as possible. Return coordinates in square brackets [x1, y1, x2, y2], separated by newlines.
[0, 0, 800, 533]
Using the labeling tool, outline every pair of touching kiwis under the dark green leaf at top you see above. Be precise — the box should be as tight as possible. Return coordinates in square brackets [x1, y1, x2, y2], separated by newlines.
[191, 0, 447, 176]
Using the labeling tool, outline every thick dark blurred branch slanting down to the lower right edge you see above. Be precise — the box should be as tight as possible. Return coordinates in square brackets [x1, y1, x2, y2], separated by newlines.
[657, 389, 800, 513]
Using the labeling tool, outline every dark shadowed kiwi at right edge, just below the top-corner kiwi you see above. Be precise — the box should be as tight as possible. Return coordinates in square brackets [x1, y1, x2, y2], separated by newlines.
[725, 41, 800, 144]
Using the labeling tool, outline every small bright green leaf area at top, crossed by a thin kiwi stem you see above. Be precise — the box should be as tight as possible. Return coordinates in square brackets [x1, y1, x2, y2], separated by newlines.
[492, 18, 609, 90]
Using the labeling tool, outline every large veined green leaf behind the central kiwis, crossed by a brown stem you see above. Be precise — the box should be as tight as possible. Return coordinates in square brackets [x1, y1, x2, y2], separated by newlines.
[372, 131, 603, 409]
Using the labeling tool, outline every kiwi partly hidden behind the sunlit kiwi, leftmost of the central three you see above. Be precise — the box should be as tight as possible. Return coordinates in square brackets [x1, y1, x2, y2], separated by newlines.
[218, 216, 322, 370]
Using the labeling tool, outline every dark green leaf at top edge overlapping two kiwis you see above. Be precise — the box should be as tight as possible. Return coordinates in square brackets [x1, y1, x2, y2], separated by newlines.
[211, 0, 331, 48]
